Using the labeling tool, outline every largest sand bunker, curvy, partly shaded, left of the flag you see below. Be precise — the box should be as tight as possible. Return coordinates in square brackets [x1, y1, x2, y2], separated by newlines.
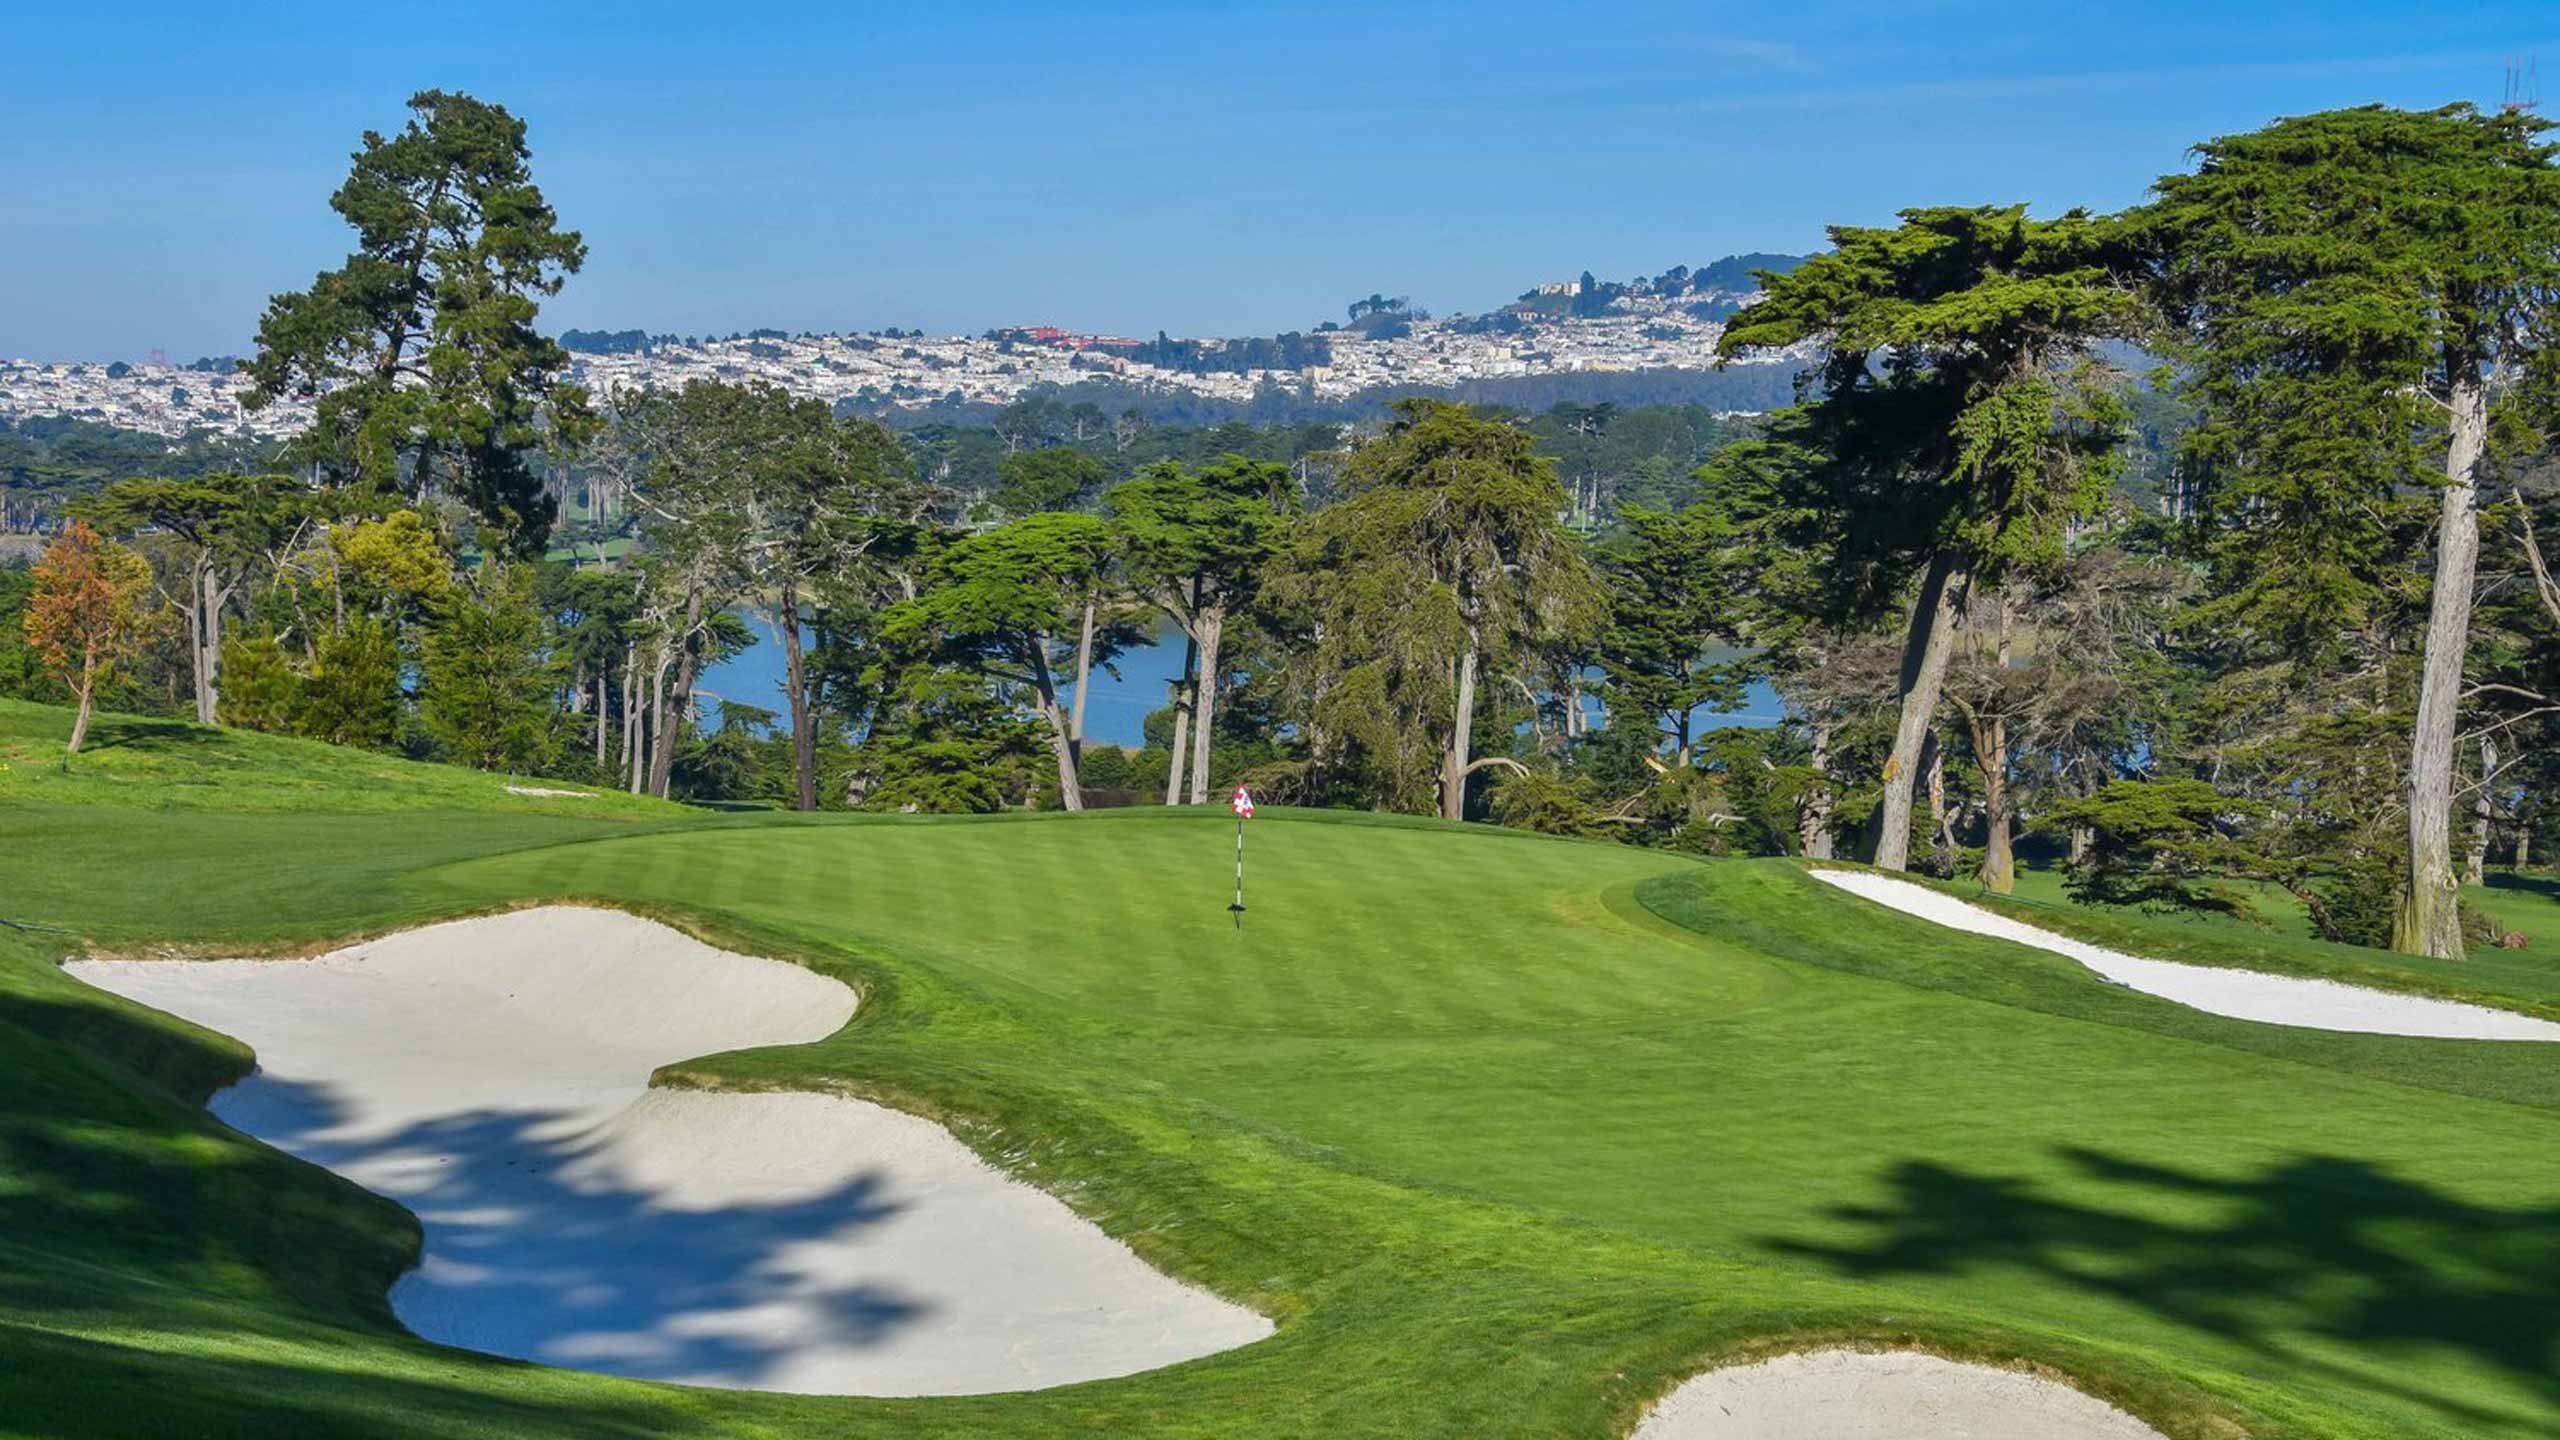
[67, 910, 1272, 1394]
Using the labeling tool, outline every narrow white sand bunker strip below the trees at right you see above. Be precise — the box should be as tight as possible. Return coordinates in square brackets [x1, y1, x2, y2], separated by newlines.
[1812, 871, 2560, 1040]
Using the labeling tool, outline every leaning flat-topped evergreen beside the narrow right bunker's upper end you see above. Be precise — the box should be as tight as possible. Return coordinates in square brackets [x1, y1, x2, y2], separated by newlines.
[1718, 205, 2140, 869]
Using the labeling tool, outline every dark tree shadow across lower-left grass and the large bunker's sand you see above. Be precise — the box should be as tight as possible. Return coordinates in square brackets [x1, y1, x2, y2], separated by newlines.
[0, 986, 929, 1437]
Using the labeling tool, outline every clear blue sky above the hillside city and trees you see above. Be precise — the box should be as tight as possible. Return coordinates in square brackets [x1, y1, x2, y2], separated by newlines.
[0, 0, 2560, 359]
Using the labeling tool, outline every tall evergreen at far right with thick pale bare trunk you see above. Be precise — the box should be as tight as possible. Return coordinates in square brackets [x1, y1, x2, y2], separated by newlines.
[2138, 105, 2560, 956]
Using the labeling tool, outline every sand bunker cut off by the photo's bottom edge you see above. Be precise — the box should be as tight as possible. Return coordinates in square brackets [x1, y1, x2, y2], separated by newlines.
[1633, 1350, 2161, 1440]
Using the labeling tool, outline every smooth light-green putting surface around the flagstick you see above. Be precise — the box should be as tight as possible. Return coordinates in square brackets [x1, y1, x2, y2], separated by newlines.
[428, 810, 1787, 1040]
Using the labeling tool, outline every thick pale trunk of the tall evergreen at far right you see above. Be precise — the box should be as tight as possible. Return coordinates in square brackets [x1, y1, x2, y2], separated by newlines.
[2391, 369, 2488, 961]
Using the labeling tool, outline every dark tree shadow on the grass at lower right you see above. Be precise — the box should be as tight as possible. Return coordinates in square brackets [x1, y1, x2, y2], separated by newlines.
[1772, 1148, 2560, 1425]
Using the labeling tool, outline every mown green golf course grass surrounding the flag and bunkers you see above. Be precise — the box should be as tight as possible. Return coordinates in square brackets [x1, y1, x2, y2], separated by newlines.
[0, 702, 2560, 1440]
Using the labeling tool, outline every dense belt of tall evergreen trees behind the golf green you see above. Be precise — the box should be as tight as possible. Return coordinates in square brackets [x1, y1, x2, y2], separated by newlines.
[15, 92, 2560, 956]
